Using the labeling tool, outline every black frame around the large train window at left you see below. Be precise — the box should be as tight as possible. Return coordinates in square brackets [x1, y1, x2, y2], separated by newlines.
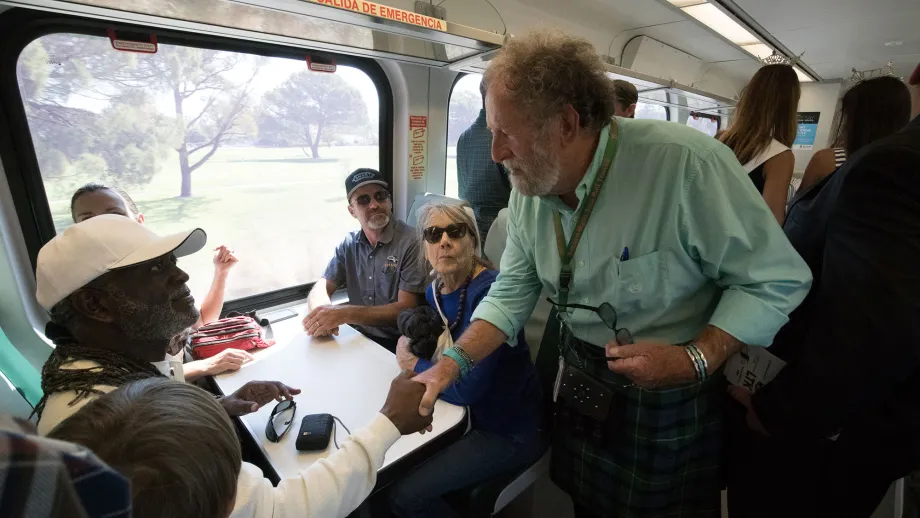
[0, 8, 393, 314]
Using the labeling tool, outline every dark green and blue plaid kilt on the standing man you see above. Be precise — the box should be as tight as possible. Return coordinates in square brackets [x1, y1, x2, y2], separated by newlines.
[550, 326, 725, 518]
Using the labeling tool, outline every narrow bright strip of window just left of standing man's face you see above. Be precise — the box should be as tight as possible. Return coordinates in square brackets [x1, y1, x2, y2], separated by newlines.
[444, 74, 482, 198]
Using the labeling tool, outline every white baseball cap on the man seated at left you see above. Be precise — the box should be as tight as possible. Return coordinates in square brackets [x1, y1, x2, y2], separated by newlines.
[35, 214, 208, 311]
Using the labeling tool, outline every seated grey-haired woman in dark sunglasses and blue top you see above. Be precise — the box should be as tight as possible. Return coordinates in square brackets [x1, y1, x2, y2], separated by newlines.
[390, 204, 544, 518]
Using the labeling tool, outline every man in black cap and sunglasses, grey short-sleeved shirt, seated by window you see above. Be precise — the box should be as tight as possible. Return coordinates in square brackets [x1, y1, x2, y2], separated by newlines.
[303, 168, 428, 351]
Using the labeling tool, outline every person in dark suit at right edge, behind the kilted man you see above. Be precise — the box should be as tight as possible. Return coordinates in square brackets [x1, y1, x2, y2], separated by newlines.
[727, 65, 920, 518]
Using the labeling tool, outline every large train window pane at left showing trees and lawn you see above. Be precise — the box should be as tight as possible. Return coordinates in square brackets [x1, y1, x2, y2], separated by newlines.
[16, 33, 388, 300]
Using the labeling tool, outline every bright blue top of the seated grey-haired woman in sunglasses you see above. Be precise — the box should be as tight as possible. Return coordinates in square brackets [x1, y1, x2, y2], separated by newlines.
[415, 270, 541, 436]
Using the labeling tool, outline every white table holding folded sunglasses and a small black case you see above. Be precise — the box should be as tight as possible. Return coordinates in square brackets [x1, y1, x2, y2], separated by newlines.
[214, 318, 466, 486]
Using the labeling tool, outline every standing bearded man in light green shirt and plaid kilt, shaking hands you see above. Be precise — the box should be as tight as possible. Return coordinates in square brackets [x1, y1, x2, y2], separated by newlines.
[415, 32, 811, 517]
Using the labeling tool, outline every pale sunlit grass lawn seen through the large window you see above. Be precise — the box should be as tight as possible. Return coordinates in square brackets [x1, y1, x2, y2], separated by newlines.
[46, 146, 382, 301]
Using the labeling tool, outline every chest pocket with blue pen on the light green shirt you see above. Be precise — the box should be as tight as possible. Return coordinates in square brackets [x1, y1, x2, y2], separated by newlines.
[616, 250, 669, 313]
